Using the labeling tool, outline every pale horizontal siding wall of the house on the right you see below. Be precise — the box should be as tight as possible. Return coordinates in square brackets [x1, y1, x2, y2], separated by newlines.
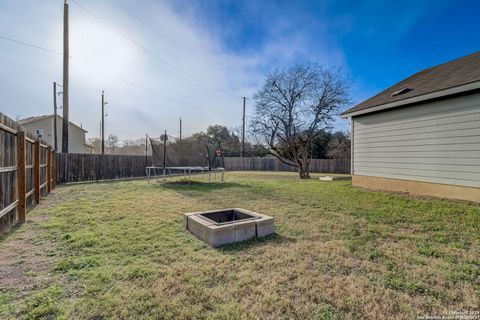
[352, 93, 480, 187]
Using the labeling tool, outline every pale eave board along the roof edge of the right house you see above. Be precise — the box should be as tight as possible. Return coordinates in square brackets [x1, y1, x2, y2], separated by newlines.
[340, 81, 480, 119]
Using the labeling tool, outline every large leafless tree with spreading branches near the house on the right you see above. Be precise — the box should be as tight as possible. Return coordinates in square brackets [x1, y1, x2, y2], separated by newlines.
[250, 64, 349, 179]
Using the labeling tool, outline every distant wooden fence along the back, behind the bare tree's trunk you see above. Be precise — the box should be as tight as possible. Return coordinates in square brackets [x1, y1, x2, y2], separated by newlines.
[219, 157, 350, 174]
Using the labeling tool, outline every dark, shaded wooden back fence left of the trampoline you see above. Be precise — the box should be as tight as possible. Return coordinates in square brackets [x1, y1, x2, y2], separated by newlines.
[56, 153, 152, 183]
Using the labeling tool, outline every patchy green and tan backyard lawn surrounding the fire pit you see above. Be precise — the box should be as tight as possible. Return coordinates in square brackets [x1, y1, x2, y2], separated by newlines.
[0, 172, 480, 319]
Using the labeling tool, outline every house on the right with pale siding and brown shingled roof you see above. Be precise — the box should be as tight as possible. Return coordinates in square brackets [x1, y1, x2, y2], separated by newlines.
[342, 52, 480, 202]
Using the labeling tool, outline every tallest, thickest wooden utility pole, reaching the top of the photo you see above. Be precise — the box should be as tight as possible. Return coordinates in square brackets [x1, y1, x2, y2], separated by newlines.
[61, 0, 70, 153]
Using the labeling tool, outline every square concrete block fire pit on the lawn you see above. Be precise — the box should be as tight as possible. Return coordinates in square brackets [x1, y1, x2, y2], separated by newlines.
[184, 208, 275, 247]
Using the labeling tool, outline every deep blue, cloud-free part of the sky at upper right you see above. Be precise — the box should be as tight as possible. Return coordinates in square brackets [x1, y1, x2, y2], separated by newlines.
[191, 0, 480, 101]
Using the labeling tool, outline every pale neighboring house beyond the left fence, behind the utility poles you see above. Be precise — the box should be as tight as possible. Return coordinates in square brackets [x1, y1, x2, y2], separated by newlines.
[18, 115, 92, 153]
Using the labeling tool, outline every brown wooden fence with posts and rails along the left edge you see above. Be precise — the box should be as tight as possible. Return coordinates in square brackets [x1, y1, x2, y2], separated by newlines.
[0, 113, 56, 235]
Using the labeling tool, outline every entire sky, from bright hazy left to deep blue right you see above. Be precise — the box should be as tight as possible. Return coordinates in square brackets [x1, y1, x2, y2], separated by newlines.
[0, 0, 480, 139]
